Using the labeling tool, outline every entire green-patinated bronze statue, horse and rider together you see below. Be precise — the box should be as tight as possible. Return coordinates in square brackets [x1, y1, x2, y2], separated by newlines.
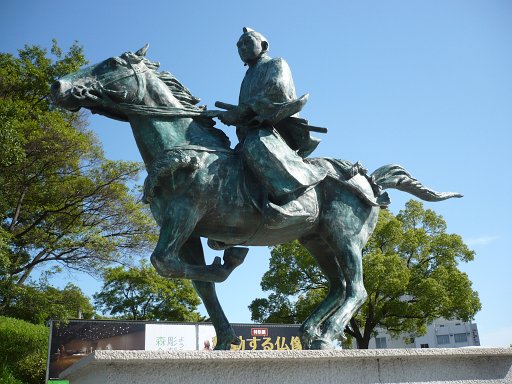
[52, 28, 461, 349]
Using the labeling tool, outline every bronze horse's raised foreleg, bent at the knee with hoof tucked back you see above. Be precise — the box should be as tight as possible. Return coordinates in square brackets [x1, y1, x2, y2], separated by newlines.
[151, 200, 247, 282]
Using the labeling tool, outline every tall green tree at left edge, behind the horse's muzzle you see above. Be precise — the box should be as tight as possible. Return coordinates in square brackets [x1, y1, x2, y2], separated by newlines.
[0, 41, 155, 313]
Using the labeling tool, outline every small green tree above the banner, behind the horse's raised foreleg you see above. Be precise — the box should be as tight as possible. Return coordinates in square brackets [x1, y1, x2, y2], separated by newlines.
[94, 260, 203, 321]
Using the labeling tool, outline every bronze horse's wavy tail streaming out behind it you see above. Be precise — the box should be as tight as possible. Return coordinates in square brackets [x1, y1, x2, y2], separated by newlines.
[371, 164, 463, 201]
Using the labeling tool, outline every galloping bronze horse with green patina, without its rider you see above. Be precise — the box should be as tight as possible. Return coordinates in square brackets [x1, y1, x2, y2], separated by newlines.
[52, 46, 461, 350]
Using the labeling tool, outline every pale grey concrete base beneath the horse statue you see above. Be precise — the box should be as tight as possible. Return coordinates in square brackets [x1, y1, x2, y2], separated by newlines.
[61, 348, 512, 384]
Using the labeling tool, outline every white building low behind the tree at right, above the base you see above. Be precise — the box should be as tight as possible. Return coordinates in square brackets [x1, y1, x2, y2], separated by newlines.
[360, 319, 480, 349]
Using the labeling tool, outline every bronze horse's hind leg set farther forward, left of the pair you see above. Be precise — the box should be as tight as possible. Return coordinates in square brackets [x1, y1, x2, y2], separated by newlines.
[299, 235, 345, 349]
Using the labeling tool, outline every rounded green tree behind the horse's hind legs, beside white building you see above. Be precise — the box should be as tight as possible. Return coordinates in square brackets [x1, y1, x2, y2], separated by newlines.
[249, 200, 481, 349]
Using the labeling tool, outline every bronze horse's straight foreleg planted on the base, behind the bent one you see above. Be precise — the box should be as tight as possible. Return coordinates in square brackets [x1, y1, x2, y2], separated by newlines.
[180, 237, 240, 350]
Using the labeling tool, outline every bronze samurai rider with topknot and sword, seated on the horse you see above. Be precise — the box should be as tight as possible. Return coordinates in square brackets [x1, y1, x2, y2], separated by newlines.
[216, 27, 344, 228]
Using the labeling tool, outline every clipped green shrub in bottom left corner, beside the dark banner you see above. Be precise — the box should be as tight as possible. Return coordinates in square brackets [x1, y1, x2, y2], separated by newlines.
[0, 316, 49, 384]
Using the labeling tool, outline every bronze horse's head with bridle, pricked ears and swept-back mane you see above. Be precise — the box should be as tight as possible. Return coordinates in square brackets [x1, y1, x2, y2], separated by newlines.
[51, 44, 199, 121]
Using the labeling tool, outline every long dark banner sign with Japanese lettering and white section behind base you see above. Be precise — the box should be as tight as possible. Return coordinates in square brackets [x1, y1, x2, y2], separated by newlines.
[47, 320, 302, 379]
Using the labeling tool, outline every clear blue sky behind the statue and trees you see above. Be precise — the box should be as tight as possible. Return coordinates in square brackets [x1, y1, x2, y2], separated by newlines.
[0, 0, 512, 346]
